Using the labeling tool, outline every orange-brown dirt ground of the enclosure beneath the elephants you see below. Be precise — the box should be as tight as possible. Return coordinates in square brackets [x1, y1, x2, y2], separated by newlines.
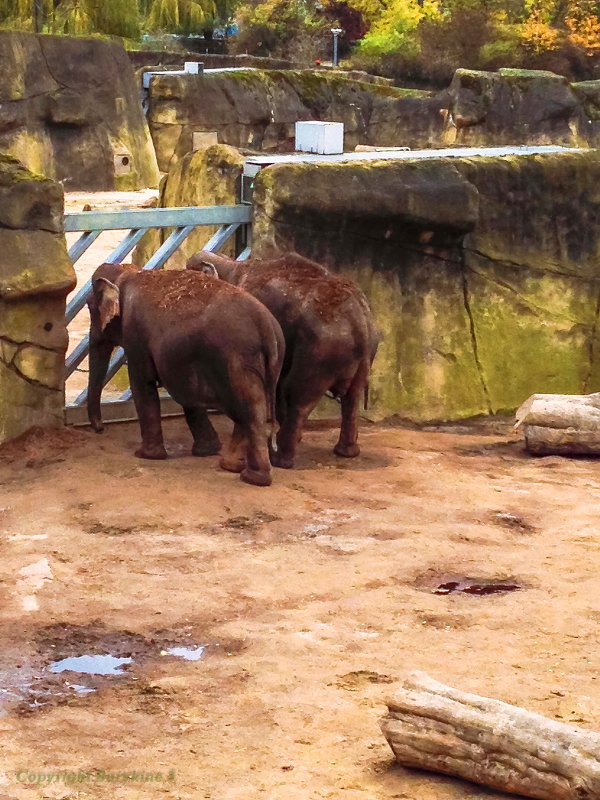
[0, 418, 600, 800]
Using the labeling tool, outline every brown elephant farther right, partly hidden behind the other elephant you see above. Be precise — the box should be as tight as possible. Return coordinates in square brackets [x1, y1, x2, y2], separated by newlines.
[187, 250, 379, 469]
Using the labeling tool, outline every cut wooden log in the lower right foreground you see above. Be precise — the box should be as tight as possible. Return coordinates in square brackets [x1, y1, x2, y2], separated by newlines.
[381, 672, 600, 800]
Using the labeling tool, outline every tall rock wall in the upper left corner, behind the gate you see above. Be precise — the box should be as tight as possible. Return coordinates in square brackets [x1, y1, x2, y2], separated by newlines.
[0, 31, 159, 191]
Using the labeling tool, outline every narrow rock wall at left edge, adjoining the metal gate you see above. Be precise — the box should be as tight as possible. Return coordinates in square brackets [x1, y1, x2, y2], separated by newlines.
[0, 156, 75, 442]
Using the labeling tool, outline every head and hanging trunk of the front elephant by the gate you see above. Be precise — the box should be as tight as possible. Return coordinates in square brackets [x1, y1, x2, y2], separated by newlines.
[87, 264, 139, 433]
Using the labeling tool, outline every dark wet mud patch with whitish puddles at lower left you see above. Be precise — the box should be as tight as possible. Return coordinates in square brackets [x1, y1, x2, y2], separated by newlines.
[0, 622, 244, 714]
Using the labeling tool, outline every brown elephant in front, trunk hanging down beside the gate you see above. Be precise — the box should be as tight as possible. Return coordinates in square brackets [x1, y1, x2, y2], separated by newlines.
[88, 264, 285, 486]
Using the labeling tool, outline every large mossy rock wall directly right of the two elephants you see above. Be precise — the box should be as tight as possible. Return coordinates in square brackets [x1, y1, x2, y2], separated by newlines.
[253, 151, 600, 421]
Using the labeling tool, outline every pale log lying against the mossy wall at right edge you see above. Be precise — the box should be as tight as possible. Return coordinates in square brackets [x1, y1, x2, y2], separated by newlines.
[515, 392, 600, 455]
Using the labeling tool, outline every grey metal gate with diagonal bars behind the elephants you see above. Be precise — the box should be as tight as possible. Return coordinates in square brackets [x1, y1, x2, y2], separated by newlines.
[65, 205, 252, 425]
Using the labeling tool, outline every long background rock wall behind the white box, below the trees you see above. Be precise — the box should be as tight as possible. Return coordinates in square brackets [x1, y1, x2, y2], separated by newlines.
[148, 69, 600, 171]
